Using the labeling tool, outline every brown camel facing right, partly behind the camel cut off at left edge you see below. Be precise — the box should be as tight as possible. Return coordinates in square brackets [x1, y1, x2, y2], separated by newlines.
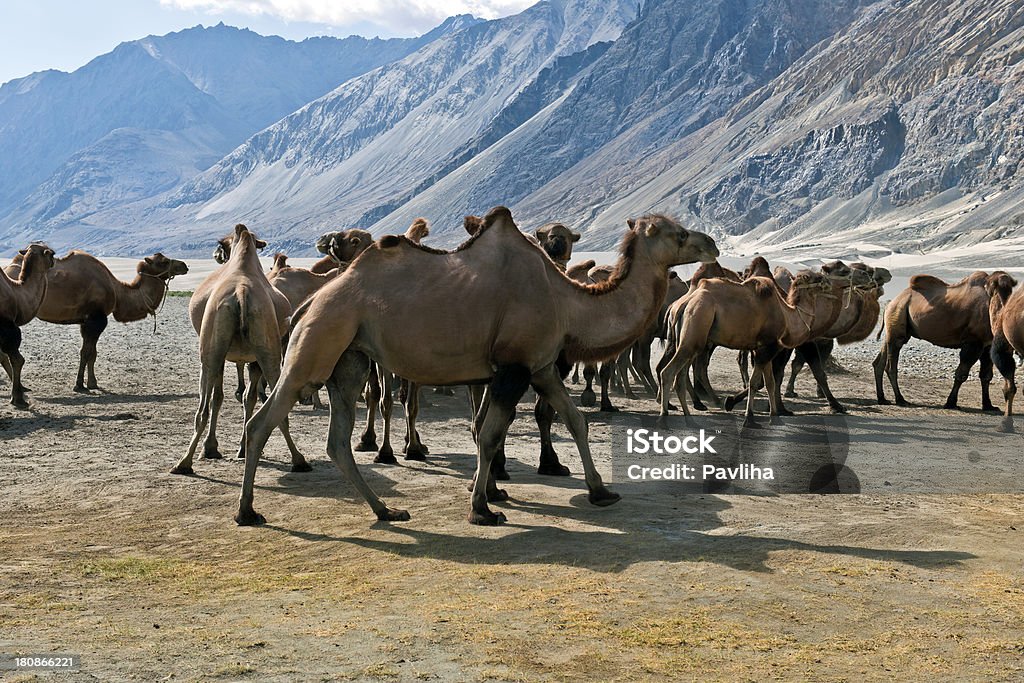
[6, 251, 188, 393]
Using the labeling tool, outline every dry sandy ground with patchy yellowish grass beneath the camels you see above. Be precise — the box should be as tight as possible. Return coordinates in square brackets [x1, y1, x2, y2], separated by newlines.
[0, 298, 1024, 681]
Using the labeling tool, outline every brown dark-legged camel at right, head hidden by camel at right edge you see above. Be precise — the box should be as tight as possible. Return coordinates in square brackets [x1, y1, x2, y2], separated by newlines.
[871, 270, 1006, 411]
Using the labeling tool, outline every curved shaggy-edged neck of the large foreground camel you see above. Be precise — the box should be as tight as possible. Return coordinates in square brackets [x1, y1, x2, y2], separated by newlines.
[566, 239, 669, 361]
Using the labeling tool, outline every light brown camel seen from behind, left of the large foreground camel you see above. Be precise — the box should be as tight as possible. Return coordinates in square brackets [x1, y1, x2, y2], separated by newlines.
[171, 223, 312, 474]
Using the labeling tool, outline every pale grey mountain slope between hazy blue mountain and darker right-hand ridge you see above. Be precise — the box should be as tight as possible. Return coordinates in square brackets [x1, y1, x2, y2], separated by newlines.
[149, 0, 636, 254]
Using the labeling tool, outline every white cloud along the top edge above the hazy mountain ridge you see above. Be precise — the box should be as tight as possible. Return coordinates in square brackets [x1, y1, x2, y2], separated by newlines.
[160, 0, 537, 32]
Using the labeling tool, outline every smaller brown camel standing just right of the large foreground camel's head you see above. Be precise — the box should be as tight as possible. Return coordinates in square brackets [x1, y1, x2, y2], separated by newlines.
[659, 271, 840, 428]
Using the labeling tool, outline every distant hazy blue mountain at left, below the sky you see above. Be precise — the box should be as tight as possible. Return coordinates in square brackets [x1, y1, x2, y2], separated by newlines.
[0, 15, 478, 253]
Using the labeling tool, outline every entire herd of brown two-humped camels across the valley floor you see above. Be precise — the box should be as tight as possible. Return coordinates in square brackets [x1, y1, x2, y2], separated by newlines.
[0, 207, 1024, 524]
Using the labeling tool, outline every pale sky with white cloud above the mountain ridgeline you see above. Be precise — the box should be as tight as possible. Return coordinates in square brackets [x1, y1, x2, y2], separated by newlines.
[0, 0, 536, 83]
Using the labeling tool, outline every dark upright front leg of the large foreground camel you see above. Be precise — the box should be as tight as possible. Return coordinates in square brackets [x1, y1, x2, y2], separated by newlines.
[469, 366, 529, 526]
